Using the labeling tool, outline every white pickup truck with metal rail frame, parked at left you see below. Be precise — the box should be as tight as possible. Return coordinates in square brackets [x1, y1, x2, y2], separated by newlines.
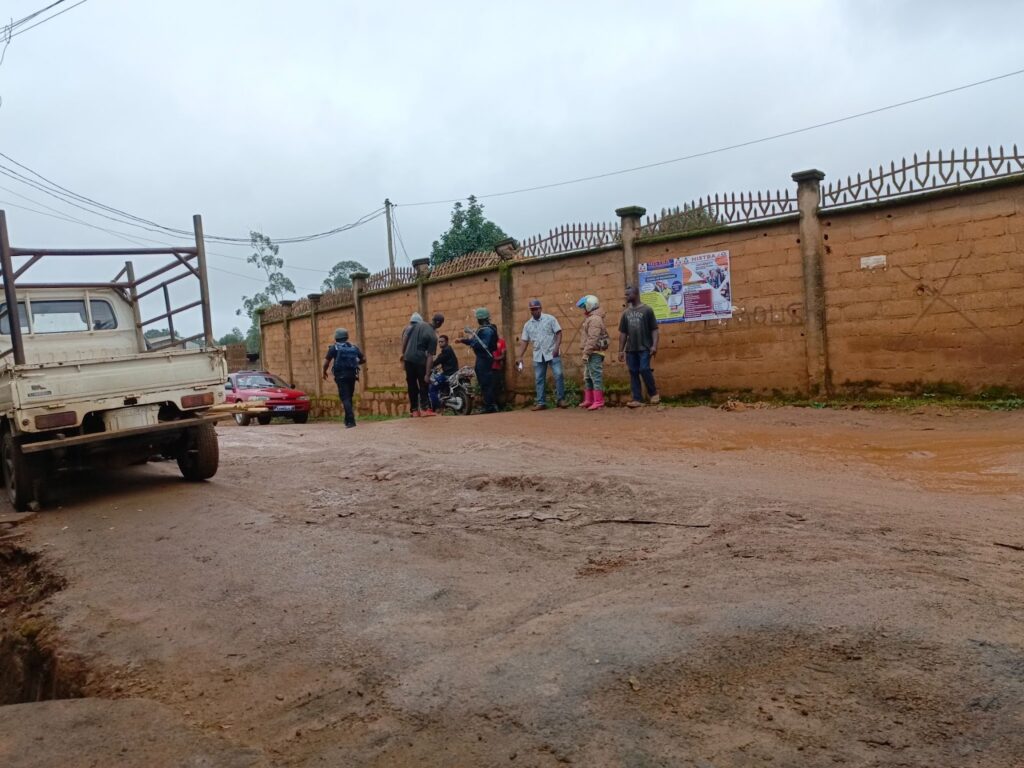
[0, 211, 227, 509]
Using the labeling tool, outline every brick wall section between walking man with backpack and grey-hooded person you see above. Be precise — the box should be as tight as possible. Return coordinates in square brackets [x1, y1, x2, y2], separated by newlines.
[362, 287, 420, 387]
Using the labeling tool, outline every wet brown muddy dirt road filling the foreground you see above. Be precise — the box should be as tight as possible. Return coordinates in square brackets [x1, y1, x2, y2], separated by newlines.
[0, 409, 1024, 768]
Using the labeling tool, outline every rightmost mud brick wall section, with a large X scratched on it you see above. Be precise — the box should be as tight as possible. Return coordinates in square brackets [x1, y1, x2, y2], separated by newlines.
[823, 185, 1024, 390]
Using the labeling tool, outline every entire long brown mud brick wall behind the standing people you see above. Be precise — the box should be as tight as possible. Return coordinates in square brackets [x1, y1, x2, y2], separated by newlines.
[263, 177, 1024, 405]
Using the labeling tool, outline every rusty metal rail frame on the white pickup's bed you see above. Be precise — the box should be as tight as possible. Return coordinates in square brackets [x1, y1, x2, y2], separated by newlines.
[0, 210, 215, 366]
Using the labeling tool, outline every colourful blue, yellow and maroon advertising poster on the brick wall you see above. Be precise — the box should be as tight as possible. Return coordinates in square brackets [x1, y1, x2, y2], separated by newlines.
[639, 251, 732, 323]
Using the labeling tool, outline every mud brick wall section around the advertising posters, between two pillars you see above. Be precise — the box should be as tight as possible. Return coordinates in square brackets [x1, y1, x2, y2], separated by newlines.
[637, 221, 807, 392]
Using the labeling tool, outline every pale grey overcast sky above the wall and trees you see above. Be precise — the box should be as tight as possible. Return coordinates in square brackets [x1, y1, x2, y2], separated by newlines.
[0, 0, 1024, 335]
